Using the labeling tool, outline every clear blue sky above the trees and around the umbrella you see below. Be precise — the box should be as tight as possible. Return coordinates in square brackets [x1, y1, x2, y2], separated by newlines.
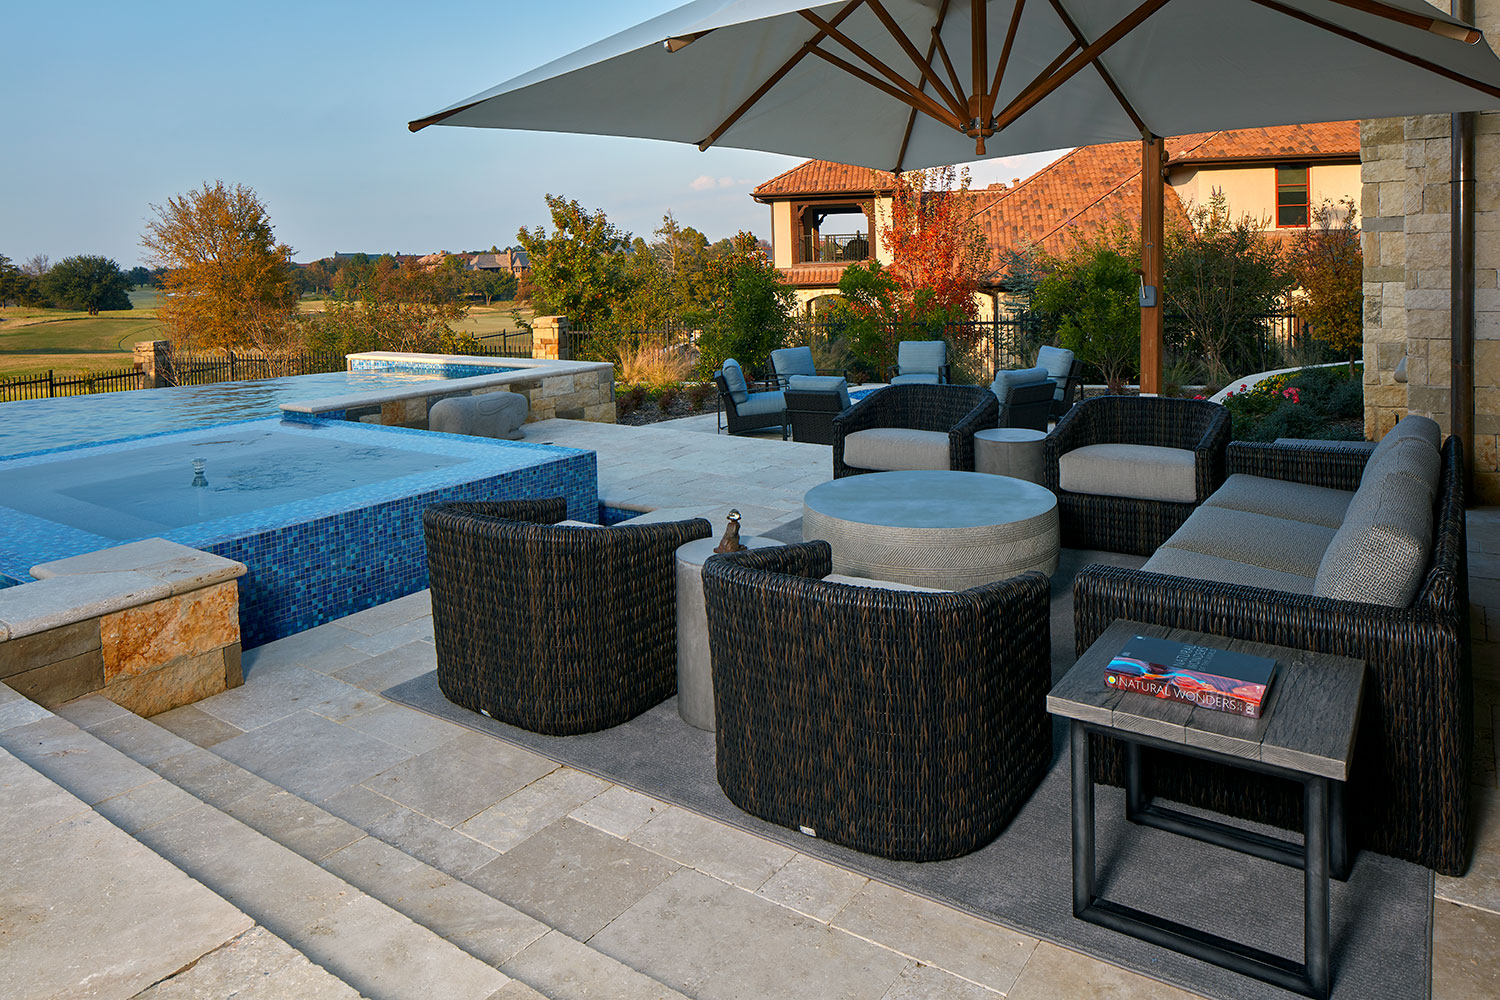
[0, 0, 1050, 267]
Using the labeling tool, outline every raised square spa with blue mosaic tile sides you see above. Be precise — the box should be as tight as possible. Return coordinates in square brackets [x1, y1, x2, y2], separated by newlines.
[0, 416, 599, 648]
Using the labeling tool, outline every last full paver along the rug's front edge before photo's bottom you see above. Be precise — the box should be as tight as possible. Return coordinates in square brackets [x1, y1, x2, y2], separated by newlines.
[833, 882, 1037, 993]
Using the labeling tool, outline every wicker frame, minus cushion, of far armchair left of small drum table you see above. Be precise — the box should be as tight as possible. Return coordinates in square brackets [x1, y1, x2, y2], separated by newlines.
[833, 385, 1001, 480]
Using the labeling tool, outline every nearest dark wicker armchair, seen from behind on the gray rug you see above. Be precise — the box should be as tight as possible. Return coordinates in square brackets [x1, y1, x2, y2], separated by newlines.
[704, 541, 1052, 861]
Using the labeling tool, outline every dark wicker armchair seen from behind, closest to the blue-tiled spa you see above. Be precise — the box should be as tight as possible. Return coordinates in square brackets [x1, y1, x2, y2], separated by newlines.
[422, 498, 713, 736]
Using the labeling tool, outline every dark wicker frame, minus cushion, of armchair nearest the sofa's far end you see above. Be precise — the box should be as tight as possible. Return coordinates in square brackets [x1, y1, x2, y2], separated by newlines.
[1043, 396, 1230, 554]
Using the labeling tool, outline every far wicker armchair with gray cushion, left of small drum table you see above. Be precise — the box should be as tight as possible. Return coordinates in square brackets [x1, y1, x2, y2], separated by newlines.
[834, 385, 1001, 480]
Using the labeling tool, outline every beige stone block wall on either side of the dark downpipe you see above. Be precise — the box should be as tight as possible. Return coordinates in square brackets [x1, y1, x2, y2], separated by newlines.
[1361, 0, 1500, 504]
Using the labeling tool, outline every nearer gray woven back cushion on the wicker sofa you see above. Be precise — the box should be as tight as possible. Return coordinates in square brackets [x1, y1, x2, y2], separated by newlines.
[1313, 472, 1433, 607]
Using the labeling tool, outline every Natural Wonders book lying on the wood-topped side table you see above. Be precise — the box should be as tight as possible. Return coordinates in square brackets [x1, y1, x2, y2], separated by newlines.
[1104, 636, 1277, 718]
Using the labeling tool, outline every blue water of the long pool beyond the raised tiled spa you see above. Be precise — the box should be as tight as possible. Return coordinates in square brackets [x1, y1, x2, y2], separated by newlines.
[0, 364, 512, 457]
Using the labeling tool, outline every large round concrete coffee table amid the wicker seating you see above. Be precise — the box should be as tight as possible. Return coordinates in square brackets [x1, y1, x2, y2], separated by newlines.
[803, 472, 1058, 591]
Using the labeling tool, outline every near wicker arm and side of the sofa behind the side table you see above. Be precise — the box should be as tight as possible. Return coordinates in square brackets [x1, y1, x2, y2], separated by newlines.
[1074, 439, 1473, 876]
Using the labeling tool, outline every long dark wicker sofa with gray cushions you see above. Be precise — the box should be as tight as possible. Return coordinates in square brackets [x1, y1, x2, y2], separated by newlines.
[1074, 417, 1473, 876]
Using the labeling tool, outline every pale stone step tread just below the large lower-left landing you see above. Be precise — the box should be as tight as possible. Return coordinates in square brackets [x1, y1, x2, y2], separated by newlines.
[0, 696, 513, 1000]
